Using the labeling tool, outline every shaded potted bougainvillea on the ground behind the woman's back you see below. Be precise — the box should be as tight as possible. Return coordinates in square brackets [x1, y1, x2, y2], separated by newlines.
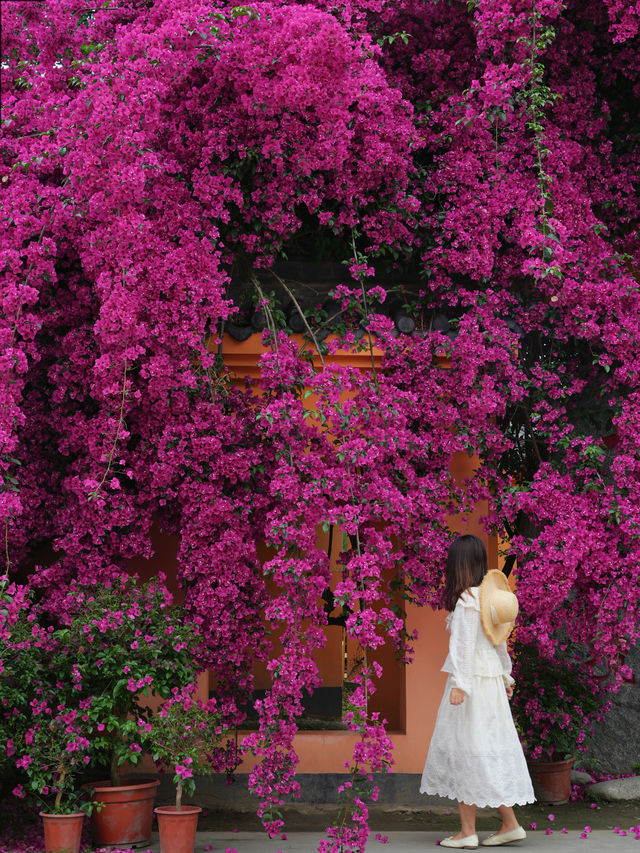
[512, 643, 608, 804]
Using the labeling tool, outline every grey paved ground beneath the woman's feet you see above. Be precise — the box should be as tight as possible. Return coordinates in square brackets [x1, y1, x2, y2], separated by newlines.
[141, 827, 640, 853]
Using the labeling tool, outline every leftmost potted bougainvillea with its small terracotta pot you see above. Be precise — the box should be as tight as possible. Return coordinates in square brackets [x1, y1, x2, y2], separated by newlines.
[0, 583, 92, 853]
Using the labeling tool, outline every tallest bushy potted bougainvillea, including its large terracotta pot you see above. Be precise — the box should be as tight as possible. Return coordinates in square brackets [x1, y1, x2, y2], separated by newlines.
[63, 576, 197, 846]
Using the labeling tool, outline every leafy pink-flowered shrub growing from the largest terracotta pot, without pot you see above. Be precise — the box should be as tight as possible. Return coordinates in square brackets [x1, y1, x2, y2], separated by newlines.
[57, 578, 201, 785]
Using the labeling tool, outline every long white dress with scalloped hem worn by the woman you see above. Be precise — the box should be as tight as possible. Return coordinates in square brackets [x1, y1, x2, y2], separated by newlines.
[420, 587, 535, 808]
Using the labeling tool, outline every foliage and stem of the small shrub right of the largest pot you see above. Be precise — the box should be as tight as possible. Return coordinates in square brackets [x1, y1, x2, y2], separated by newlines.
[138, 684, 228, 810]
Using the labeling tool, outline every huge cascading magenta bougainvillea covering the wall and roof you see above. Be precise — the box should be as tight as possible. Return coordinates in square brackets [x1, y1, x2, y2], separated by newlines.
[0, 0, 640, 850]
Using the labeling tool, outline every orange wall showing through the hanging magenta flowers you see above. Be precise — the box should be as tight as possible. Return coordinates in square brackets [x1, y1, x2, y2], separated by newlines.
[131, 335, 500, 773]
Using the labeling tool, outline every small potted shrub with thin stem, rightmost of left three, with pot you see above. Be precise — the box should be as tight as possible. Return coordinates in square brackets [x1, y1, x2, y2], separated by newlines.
[146, 683, 228, 853]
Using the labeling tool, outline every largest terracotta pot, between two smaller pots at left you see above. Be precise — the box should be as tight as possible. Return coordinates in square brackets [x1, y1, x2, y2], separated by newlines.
[88, 779, 160, 847]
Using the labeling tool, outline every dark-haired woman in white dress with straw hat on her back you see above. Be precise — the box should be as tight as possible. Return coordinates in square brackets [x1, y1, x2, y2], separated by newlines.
[420, 536, 535, 849]
